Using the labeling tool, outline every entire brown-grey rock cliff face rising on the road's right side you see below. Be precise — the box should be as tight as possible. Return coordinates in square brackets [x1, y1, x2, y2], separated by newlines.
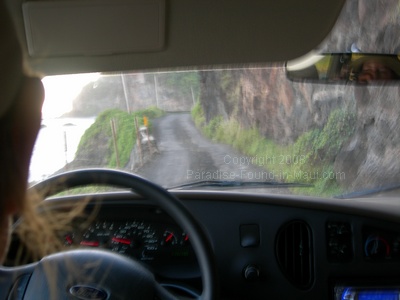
[200, 0, 400, 190]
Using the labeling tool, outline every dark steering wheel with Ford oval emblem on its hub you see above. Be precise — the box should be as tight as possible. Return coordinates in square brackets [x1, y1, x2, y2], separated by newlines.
[0, 169, 217, 300]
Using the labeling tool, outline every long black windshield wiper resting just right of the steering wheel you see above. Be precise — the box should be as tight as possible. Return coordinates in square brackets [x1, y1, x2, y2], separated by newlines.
[167, 180, 314, 190]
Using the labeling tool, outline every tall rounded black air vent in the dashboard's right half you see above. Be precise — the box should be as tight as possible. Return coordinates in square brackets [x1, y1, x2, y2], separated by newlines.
[276, 220, 314, 289]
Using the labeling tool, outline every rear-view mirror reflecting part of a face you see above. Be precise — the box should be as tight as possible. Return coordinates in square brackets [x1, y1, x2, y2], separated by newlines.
[286, 53, 400, 84]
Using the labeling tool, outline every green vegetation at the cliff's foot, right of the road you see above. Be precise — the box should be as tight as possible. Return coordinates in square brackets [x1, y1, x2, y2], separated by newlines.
[192, 103, 356, 196]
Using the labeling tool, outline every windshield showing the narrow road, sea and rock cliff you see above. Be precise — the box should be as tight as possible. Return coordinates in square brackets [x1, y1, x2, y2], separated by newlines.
[30, 1, 400, 197]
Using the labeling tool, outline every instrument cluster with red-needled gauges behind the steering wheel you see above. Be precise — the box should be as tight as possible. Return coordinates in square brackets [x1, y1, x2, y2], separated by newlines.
[63, 220, 196, 265]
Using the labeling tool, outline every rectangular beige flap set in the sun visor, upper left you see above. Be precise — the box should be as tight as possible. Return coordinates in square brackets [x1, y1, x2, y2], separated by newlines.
[23, 0, 165, 57]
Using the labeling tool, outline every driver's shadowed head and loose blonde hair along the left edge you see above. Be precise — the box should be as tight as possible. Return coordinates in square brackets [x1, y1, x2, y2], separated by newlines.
[0, 0, 96, 263]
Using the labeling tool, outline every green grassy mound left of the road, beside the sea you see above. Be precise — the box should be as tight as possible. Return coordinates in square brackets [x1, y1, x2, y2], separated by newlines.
[77, 107, 163, 168]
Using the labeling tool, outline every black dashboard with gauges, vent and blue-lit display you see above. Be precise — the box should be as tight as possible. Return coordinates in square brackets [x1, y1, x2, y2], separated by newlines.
[7, 191, 400, 300]
